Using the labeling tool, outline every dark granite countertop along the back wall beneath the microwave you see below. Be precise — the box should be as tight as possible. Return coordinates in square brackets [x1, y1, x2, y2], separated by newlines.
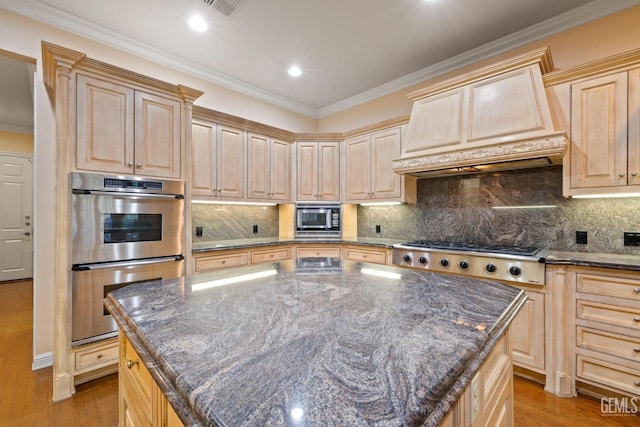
[192, 237, 401, 253]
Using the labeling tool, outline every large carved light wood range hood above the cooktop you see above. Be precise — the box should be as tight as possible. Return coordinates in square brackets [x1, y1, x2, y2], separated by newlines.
[392, 47, 567, 178]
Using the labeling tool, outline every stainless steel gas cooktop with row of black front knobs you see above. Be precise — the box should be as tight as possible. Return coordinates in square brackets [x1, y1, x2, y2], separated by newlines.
[392, 240, 547, 285]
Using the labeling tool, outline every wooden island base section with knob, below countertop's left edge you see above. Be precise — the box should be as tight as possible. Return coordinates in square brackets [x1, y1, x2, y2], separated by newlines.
[118, 333, 184, 427]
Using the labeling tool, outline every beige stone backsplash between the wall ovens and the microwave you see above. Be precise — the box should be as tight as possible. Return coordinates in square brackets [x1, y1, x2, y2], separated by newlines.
[191, 204, 279, 242]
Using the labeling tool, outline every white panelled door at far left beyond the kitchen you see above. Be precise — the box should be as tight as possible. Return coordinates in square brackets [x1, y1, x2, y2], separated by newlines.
[0, 155, 33, 281]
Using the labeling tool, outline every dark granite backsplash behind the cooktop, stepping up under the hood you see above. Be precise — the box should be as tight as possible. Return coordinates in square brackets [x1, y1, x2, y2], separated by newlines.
[358, 166, 640, 255]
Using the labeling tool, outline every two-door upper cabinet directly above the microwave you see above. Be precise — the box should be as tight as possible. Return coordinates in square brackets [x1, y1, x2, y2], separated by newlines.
[296, 141, 340, 201]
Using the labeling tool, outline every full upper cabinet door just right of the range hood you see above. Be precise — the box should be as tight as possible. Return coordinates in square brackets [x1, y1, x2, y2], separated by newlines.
[571, 72, 627, 188]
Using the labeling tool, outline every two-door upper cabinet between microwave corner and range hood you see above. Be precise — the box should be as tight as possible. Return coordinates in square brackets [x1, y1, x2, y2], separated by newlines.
[344, 127, 415, 203]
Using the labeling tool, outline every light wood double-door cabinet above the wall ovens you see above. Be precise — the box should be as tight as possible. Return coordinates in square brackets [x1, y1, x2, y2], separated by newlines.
[76, 74, 182, 178]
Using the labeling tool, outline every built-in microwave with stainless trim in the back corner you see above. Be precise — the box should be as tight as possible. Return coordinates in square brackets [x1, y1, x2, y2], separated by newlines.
[295, 203, 341, 237]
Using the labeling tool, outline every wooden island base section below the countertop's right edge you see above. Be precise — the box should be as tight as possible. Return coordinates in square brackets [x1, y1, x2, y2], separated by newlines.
[440, 331, 513, 427]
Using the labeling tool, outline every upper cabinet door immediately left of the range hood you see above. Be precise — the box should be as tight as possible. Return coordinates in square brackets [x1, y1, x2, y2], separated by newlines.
[371, 128, 401, 199]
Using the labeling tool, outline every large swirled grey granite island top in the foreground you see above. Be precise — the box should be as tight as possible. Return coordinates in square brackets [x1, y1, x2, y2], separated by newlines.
[105, 259, 526, 426]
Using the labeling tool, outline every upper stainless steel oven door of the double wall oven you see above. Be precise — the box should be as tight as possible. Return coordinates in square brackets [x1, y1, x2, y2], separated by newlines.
[72, 191, 184, 265]
